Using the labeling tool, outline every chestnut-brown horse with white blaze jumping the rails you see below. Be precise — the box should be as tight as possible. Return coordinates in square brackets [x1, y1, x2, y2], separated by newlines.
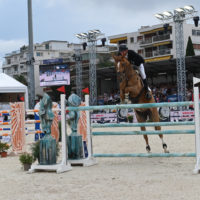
[113, 56, 169, 153]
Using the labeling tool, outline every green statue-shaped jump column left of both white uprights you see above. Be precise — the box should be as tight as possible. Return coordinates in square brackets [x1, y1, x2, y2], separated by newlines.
[39, 93, 56, 165]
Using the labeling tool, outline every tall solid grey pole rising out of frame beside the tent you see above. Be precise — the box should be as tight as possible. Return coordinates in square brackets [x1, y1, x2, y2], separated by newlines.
[27, 0, 35, 108]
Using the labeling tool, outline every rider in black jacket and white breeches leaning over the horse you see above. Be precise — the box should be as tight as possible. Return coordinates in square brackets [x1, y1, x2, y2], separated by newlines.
[119, 44, 151, 100]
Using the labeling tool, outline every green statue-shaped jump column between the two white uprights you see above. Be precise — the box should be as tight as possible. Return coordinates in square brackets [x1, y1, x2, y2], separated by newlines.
[67, 94, 83, 159]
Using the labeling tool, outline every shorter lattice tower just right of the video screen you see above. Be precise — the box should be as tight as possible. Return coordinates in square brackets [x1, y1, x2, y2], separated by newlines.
[74, 46, 82, 99]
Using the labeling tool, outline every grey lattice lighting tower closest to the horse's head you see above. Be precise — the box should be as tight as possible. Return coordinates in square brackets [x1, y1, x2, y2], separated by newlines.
[88, 34, 97, 105]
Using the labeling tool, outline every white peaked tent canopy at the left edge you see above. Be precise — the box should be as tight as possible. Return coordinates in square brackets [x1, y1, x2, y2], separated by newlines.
[0, 73, 28, 108]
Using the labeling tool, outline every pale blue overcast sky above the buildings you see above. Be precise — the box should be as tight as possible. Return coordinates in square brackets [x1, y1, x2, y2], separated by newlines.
[0, 0, 200, 70]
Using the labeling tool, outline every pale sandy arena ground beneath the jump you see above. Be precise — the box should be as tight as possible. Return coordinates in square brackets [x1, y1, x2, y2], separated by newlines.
[0, 127, 200, 200]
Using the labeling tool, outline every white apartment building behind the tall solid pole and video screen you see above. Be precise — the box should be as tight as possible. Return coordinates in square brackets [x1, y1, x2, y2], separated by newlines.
[2, 40, 76, 96]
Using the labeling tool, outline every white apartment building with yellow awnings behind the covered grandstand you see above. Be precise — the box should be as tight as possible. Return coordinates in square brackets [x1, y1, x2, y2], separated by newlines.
[108, 22, 200, 62]
